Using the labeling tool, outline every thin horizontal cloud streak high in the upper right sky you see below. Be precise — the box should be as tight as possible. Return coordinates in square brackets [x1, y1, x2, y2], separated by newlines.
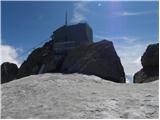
[115, 11, 155, 16]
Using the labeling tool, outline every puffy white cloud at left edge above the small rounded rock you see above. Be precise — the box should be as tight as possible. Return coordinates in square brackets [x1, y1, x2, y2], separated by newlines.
[0, 45, 22, 66]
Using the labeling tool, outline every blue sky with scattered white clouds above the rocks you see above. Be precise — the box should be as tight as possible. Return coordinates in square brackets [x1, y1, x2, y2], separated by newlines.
[1, 1, 159, 81]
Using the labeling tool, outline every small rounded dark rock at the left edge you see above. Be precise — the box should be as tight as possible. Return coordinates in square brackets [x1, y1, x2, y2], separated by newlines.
[1, 62, 18, 83]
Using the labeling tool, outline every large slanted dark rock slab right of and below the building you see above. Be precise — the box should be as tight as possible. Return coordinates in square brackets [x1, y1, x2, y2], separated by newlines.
[61, 40, 125, 83]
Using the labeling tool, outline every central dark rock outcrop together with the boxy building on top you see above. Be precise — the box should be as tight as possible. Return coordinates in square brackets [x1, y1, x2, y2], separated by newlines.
[1, 23, 125, 83]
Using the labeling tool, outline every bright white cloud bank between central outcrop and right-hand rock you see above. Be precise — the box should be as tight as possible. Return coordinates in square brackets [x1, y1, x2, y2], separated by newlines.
[114, 42, 149, 75]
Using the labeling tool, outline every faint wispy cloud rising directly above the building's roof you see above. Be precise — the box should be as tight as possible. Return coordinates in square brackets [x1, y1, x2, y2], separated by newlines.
[71, 1, 89, 23]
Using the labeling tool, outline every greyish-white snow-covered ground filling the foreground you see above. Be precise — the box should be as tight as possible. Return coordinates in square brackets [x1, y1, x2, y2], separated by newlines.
[1, 74, 159, 119]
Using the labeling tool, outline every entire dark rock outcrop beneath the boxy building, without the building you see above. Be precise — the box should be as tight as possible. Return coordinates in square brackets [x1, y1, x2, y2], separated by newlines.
[1, 40, 125, 83]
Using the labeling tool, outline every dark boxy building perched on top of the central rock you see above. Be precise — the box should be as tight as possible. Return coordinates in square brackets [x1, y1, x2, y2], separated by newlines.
[52, 23, 93, 55]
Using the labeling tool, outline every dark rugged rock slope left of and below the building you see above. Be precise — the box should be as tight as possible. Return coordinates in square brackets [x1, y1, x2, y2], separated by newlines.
[17, 41, 56, 78]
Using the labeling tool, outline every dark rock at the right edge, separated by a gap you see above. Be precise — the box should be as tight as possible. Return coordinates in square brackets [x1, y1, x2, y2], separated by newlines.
[134, 43, 159, 83]
